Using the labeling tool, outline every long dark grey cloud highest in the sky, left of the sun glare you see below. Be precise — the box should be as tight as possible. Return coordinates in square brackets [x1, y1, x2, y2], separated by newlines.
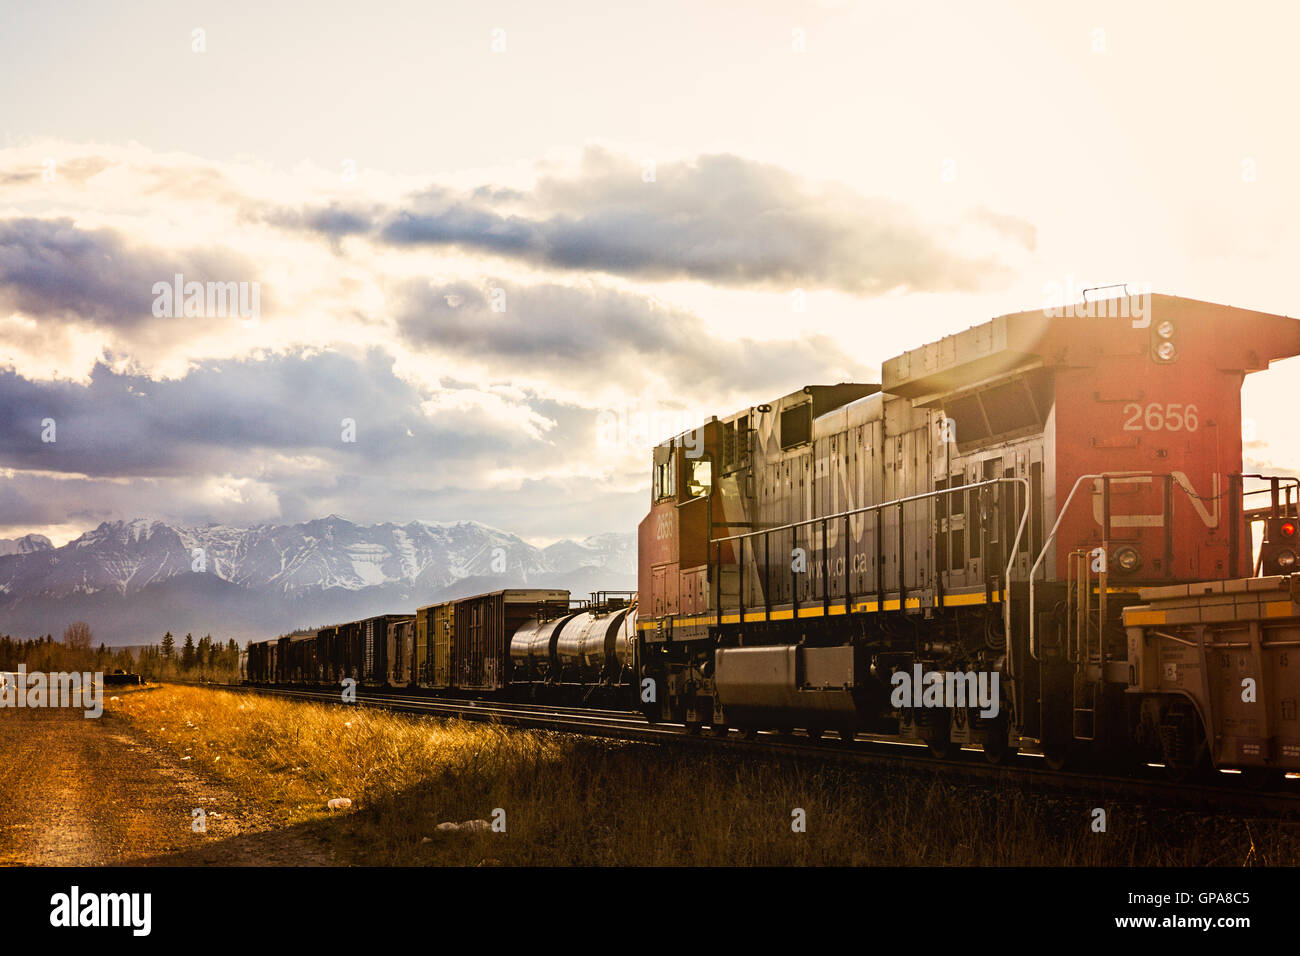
[270, 150, 1035, 294]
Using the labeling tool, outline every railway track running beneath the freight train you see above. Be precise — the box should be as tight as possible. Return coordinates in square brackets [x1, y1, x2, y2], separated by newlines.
[185, 683, 1300, 819]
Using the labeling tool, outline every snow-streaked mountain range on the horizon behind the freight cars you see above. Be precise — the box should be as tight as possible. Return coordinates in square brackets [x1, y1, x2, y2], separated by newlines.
[0, 515, 636, 646]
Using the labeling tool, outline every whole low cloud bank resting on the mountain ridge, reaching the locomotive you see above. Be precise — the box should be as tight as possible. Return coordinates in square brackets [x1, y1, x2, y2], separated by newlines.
[0, 349, 644, 546]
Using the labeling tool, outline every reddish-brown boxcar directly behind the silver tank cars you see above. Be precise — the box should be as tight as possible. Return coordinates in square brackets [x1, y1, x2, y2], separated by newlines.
[449, 588, 569, 691]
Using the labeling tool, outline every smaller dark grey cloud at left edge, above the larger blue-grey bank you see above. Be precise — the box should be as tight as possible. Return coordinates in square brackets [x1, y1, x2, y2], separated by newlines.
[0, 219, 267, 328]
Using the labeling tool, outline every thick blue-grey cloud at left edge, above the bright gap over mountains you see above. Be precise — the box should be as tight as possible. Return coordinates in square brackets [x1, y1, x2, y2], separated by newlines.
[0, 349, 543, 477]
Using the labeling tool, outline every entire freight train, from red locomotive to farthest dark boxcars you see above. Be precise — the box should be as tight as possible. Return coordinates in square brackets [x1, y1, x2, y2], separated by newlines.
[248, 295, 1300, 786]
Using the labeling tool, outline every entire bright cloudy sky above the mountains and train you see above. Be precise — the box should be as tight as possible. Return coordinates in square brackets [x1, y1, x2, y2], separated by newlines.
[0, 0, 1300, 544]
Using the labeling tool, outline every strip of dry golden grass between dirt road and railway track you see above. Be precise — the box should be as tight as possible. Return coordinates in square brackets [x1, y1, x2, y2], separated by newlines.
[111, 687, 1300, 866]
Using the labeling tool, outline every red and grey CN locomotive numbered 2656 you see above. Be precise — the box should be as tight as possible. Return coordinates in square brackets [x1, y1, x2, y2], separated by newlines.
[637, 295, 1300, 773]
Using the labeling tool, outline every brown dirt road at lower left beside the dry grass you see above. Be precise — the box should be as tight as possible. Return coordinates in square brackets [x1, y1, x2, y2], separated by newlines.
[0, 709, 333, 866]
